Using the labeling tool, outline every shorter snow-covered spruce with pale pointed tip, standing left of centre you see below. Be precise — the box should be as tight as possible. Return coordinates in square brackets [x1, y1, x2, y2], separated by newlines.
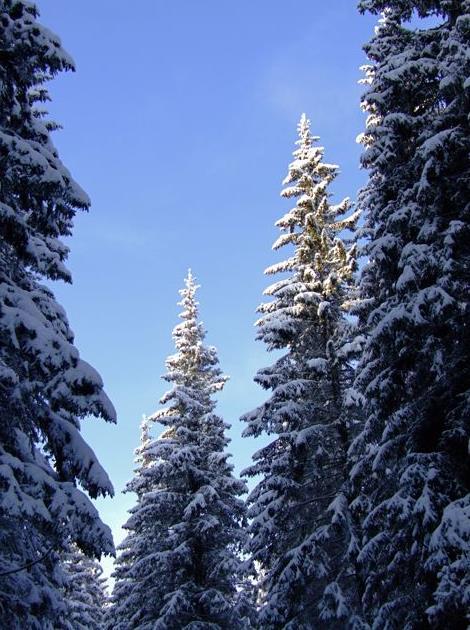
[113, 273, 250, 630]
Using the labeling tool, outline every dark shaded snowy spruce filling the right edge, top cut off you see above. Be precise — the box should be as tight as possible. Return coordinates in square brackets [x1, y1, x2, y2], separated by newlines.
[351, 0, 470, 629]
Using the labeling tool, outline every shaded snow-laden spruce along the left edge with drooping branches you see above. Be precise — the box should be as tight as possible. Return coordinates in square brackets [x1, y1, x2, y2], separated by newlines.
[0, 0, 115, 628]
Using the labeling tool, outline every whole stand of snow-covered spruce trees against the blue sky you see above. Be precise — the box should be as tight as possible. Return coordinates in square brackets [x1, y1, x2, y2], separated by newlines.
[0, 0, 470, 630]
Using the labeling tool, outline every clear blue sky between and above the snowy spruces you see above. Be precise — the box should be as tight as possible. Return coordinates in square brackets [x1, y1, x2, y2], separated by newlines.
[37, 0, 374, 576]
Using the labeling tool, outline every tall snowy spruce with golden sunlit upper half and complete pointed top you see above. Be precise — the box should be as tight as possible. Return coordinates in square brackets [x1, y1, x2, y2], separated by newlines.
[243, 115, 357, 629]
